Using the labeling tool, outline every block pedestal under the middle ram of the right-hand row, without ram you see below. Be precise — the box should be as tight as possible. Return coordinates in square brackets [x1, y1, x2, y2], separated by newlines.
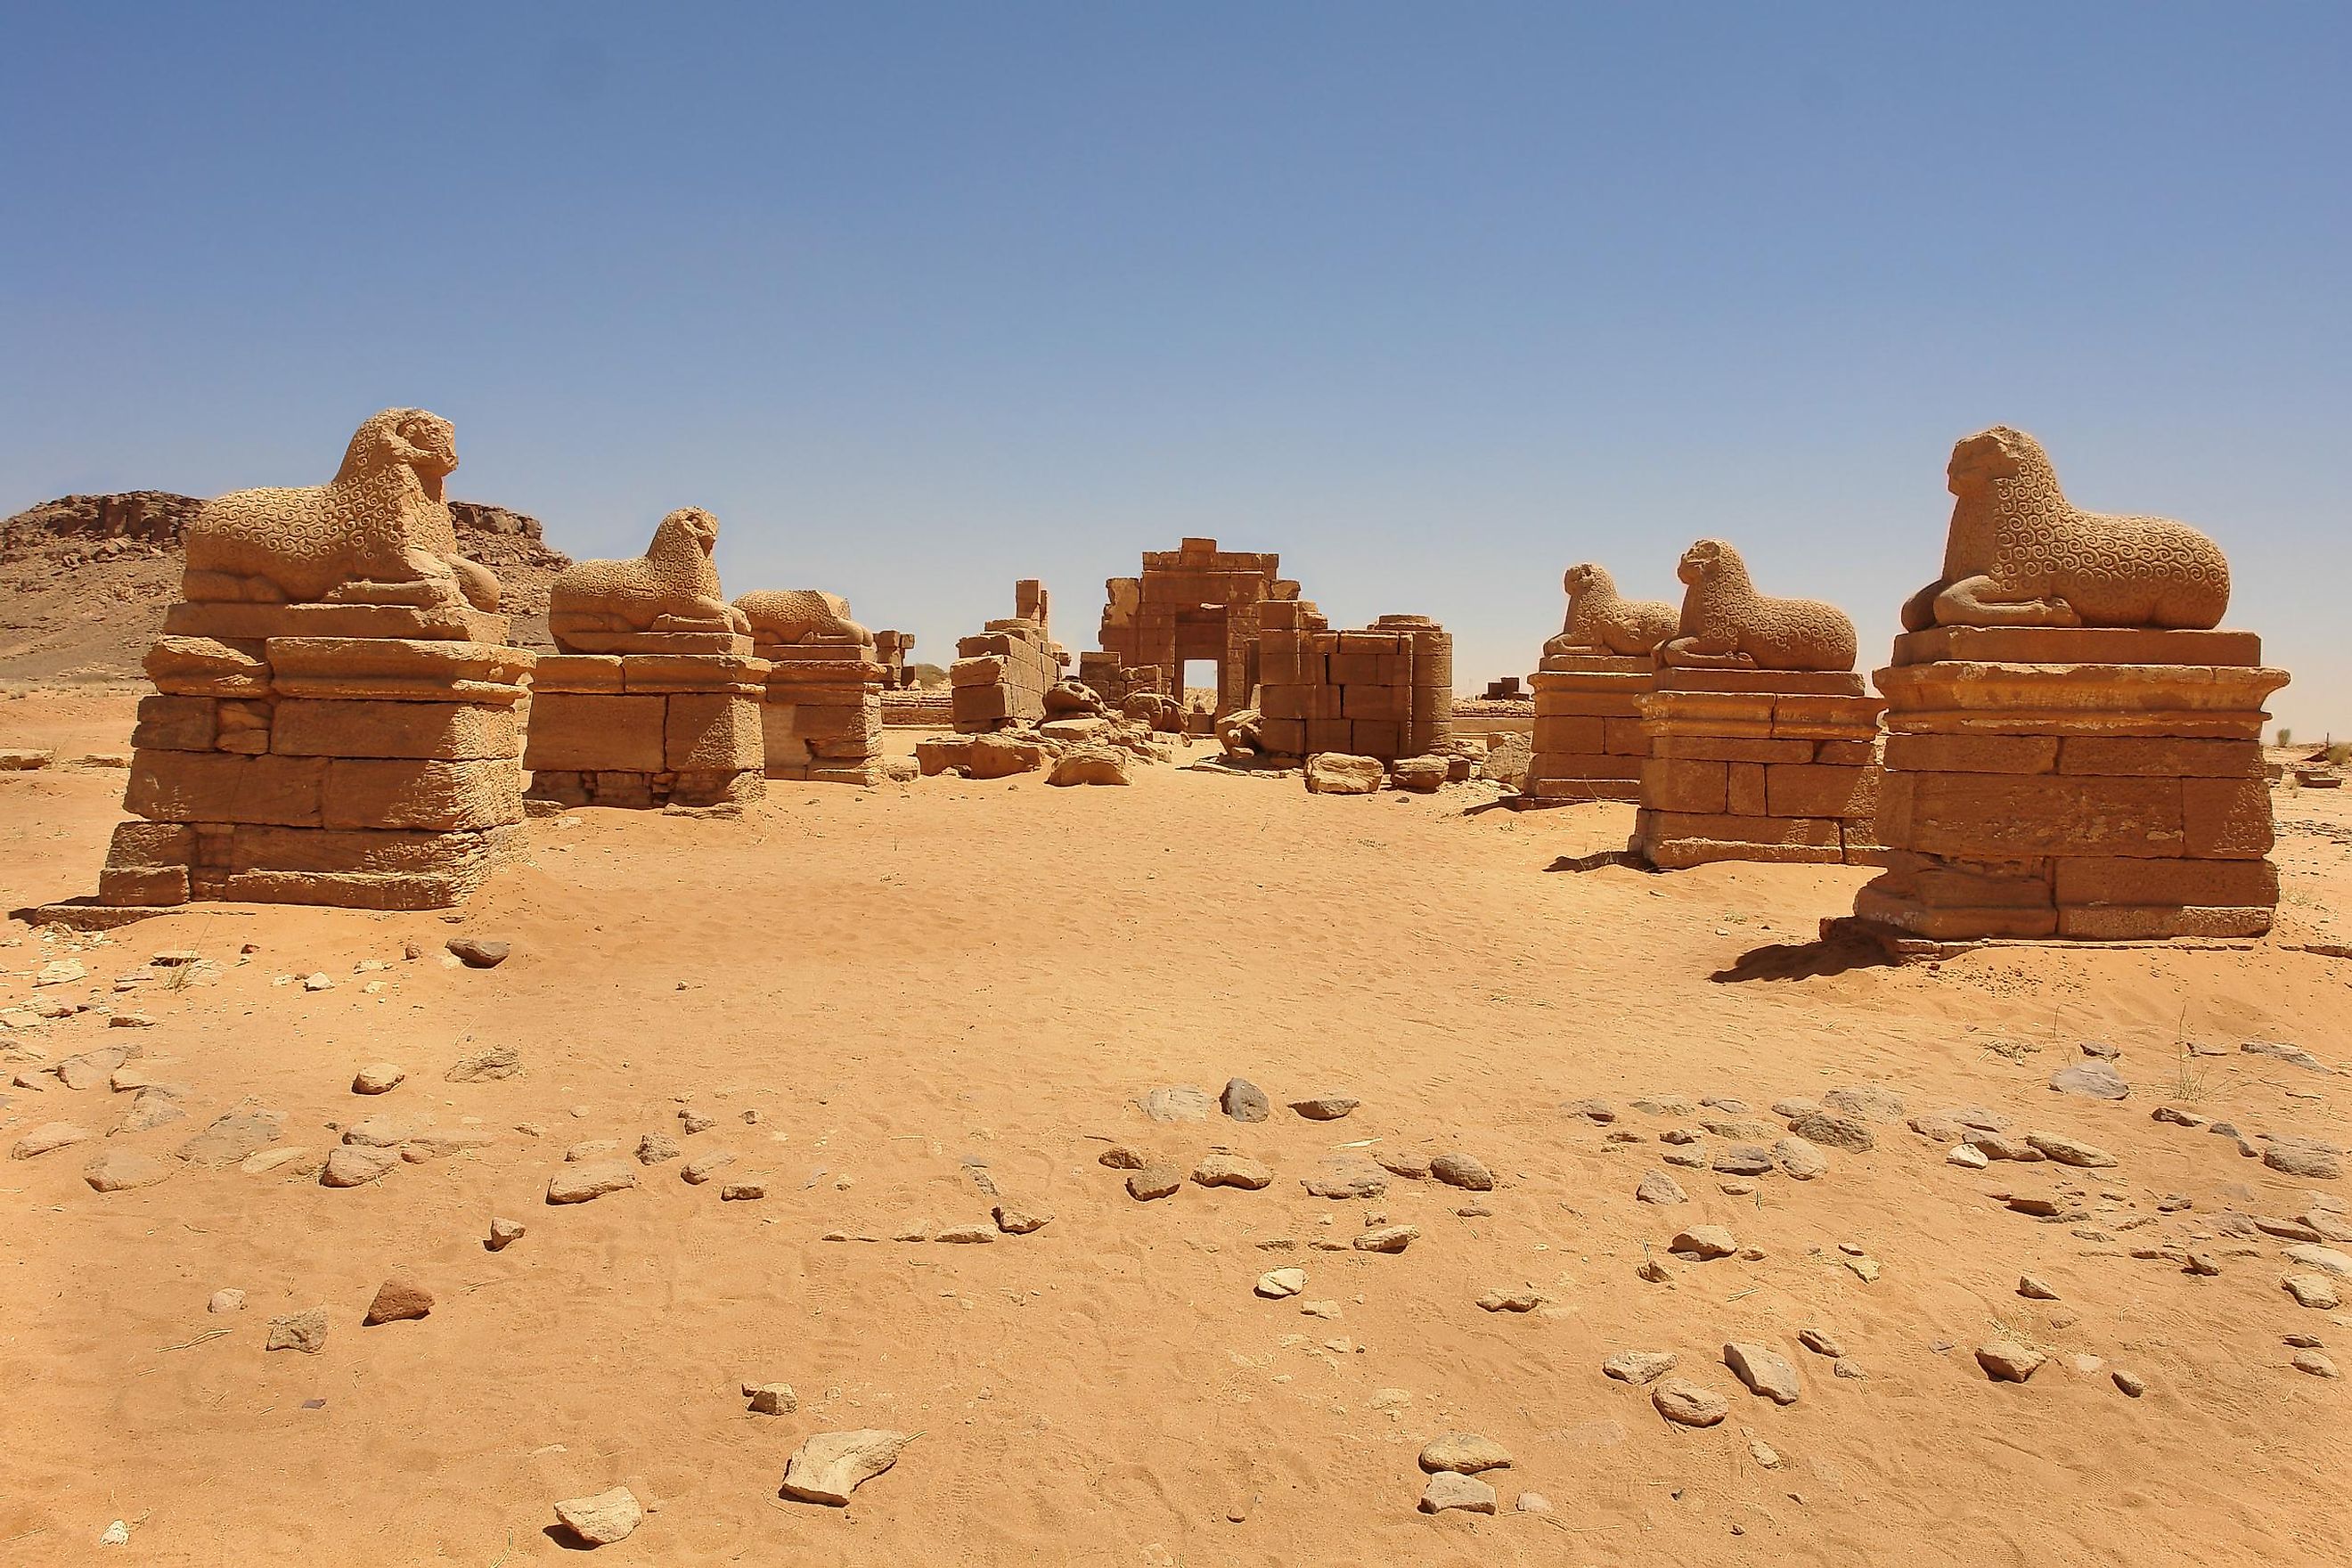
[1630, 667, 1886, 870]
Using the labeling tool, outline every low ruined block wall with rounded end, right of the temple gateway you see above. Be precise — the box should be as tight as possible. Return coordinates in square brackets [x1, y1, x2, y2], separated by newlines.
[1256, 600, 1454, 762]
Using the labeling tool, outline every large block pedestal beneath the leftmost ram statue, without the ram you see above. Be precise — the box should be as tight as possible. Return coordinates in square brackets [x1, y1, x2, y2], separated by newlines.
[99, 604, 536, 910]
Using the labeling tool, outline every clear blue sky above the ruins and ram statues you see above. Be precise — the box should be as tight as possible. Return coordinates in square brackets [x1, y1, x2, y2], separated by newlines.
[0, 0, 2352, 733]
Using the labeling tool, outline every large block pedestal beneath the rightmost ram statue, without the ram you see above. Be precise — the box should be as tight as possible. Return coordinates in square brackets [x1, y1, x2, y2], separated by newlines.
[1853, 628, 2289, 940]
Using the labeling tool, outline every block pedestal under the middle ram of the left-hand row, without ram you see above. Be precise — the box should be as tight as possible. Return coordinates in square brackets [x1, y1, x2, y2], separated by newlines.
[522, 633, 769, 809]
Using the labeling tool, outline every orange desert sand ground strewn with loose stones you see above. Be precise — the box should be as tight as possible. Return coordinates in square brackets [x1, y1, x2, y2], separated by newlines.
[0, 686, 2352, 1565]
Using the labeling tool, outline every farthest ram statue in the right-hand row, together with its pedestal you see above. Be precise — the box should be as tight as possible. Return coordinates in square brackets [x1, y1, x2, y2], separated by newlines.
[1519, 562, 1679, 806]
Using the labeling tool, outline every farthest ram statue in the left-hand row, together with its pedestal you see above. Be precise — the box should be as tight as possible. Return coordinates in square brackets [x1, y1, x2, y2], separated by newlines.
[736, 588, 884, 785]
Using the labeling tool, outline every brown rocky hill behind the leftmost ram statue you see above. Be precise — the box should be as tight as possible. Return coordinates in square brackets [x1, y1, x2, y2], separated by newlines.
[0, 489, 572, 680]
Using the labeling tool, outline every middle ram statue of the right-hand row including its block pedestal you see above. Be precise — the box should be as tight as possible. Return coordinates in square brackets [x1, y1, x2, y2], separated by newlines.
[1630, 538, 1884, 868]
